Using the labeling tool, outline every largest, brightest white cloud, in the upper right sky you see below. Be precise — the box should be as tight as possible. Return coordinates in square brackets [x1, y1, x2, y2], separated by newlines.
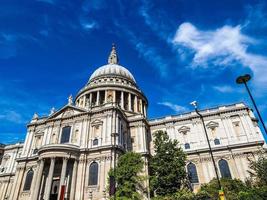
[172, 23, 267, 86]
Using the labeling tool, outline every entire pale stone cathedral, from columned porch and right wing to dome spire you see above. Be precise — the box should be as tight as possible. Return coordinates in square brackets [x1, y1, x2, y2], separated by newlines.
[0, 47, 264, 200]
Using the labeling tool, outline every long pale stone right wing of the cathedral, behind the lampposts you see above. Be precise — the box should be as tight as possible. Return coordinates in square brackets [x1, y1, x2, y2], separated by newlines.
[149, 103, 264, 190]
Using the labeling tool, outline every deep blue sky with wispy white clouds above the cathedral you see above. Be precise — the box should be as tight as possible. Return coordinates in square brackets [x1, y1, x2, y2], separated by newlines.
[0, 0, 267, 143]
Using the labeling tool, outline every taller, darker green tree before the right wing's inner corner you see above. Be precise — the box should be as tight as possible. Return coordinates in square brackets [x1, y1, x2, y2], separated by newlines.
[149, 131, 186, 196]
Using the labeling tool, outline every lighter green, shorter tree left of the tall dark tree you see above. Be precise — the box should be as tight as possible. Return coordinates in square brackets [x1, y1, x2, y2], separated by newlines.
[109, 152, 145, 200]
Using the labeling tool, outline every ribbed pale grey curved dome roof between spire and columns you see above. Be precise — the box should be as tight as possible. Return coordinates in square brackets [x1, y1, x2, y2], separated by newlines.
[89, 63, 136, 83]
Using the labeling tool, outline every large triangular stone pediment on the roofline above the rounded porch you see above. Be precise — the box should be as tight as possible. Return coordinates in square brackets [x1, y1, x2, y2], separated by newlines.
[48, 105, 86, 119]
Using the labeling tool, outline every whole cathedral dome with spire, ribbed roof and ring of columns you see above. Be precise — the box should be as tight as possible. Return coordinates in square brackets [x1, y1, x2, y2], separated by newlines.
[75, 45, 148, 115]
